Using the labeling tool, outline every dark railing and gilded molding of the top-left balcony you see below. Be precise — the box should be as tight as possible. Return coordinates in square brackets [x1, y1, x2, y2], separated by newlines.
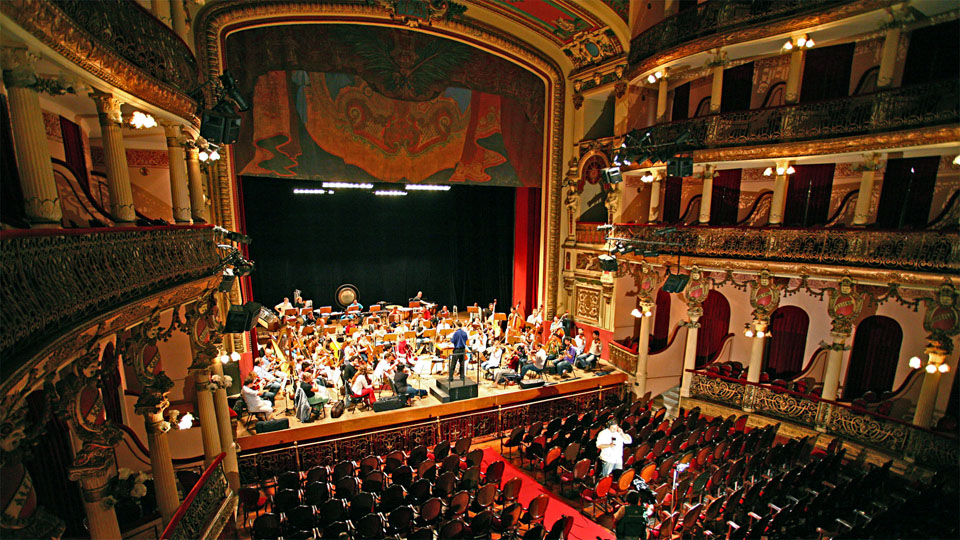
[0, 0, 200, 122]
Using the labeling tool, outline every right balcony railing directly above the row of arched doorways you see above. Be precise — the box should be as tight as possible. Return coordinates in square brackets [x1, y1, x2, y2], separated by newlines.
[612, 224, 960, 274]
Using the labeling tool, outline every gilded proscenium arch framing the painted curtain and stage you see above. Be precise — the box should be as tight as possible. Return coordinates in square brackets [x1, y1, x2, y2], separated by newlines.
[195, 1, 567, 316]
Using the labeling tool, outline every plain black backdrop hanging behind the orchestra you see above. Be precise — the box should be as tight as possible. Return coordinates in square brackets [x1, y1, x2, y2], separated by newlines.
[242, 177, 516, 311]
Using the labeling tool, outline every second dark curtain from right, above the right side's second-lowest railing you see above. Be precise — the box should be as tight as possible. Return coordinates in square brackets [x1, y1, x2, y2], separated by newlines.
[783, 163, 836, 227]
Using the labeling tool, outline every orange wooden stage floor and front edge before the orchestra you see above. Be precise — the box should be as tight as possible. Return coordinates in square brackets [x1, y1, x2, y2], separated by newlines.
[237, 361, 627, 451]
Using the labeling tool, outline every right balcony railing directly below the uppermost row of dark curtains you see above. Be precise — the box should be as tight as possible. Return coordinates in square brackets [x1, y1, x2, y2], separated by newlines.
[644, 80, 960, 150]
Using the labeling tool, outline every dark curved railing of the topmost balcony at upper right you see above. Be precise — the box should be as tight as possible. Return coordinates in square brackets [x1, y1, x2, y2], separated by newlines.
[630, 0, 849, 64]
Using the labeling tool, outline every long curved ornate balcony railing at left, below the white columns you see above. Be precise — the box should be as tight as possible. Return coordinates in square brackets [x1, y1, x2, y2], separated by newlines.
[0, 225, 220, 377]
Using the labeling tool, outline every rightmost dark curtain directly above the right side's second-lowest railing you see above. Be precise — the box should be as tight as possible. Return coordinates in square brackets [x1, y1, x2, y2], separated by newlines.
[877, 156, 940, 229]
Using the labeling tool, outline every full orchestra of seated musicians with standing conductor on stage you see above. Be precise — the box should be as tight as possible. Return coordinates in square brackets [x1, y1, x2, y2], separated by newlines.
[243, 290, 600, 426]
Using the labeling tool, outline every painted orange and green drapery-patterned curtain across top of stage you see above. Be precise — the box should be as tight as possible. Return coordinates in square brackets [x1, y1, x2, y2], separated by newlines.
[225, 24, 546, 187]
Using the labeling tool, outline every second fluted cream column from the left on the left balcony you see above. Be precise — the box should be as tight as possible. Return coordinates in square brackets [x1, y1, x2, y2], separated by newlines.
[90, 92, 137, 225]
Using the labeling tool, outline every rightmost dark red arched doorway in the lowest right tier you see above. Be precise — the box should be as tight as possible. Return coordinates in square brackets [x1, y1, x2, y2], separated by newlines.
[844, 315, 903, 400]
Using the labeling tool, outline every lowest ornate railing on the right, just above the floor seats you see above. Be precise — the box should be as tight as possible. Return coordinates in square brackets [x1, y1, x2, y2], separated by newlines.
[690, 370, 960, 467]
